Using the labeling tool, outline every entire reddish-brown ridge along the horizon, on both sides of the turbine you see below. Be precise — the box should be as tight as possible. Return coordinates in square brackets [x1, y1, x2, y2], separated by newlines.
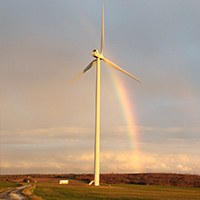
[0, 173, 200, 188]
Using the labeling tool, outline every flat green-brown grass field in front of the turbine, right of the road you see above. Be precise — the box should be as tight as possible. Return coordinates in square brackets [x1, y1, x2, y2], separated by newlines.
[34, 184, 200, 200]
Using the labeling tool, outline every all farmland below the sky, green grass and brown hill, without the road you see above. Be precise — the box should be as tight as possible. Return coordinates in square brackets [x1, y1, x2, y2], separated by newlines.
[1, 174, 200, 200]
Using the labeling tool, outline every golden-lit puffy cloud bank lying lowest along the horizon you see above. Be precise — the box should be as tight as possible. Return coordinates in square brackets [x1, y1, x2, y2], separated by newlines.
[1, 149, 200, 174]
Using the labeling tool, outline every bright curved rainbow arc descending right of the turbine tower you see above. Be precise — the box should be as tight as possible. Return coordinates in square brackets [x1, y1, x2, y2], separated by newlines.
[107, 68, 142, 173]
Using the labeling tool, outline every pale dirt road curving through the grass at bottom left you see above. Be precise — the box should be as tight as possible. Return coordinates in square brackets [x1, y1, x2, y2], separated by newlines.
[0, 185, 30, 200]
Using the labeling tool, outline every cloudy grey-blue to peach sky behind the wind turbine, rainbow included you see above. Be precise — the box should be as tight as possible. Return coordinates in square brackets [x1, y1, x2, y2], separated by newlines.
[0, 0, 200, 174]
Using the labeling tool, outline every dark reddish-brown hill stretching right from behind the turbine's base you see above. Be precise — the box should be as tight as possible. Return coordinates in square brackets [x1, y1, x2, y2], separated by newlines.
[76, 173, 200, 188]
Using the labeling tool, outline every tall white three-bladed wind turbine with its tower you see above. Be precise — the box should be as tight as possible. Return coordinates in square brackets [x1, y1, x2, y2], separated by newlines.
[66, 4, 140, 186]
